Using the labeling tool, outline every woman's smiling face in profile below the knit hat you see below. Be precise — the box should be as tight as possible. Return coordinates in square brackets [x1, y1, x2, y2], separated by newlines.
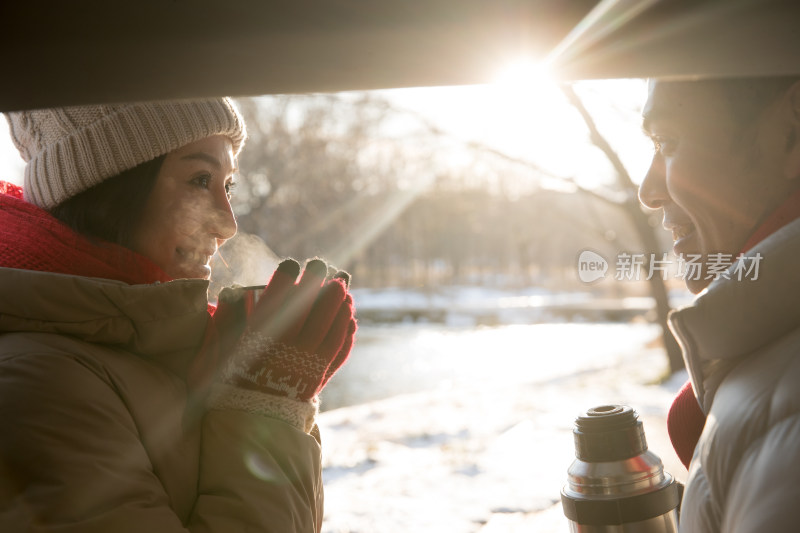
[133, 135, 236, 279]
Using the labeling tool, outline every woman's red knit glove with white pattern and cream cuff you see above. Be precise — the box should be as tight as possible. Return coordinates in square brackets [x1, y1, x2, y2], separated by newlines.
[211, 259, 356, 430]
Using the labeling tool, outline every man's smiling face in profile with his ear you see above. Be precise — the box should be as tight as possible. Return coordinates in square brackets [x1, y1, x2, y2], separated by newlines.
[639, 81, 794, 293]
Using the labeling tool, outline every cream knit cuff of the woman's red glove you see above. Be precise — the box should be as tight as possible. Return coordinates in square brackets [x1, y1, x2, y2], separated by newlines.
[208, 383, 319, 433]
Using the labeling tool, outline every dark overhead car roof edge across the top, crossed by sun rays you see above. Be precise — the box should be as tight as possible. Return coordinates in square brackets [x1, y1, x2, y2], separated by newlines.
[0, 0, 800, 110]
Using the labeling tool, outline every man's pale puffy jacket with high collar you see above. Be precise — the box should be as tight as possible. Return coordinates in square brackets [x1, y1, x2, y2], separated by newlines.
[670, 221, 800, 533]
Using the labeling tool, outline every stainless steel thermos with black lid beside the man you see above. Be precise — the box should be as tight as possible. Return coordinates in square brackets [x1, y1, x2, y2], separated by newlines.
[561, 405, 681, 533]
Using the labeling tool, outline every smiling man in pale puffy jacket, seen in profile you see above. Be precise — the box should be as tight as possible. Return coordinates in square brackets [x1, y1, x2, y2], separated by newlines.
[639, 78, 800, 533]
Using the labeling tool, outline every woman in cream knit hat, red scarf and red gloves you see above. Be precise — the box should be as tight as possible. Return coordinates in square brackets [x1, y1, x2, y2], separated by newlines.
[0, 98, 355, 533]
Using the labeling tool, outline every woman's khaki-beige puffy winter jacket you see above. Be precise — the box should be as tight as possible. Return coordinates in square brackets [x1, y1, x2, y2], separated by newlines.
[0, 268, 322, 533]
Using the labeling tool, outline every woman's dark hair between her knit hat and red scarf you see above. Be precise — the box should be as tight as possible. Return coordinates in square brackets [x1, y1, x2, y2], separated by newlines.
[50, 155, 166, 248]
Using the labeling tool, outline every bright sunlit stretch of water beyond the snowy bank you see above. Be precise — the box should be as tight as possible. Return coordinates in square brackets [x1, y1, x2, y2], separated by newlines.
[322, 323, 658, 410]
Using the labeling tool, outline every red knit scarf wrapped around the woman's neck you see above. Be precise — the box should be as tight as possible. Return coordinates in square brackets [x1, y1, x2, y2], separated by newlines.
[0, 181, 170, 285]
